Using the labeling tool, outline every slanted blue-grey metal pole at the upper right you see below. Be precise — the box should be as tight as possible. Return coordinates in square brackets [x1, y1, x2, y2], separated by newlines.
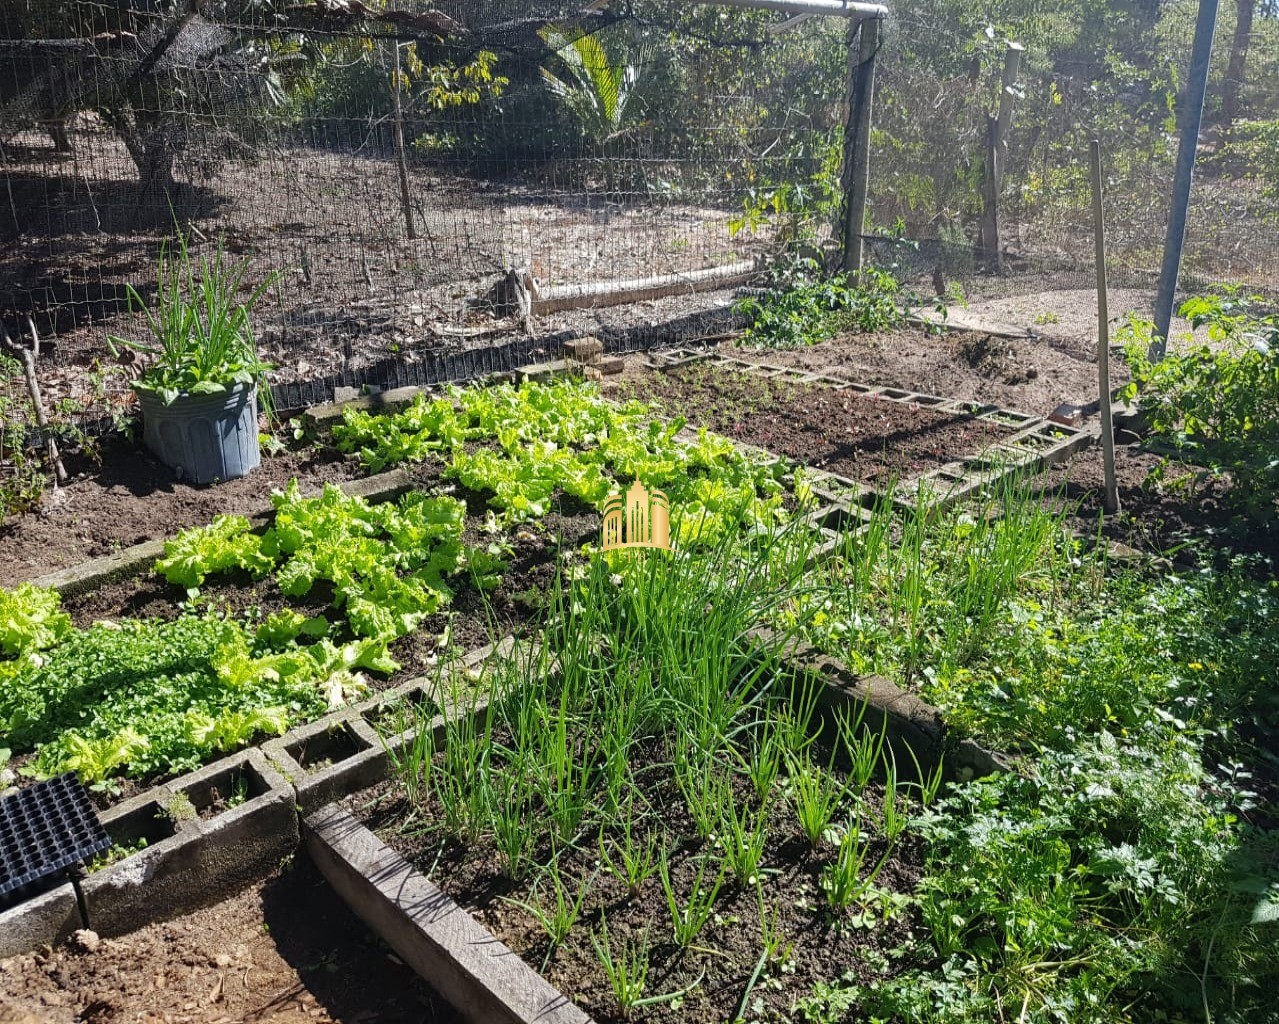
[1150, 0, 1218, 362]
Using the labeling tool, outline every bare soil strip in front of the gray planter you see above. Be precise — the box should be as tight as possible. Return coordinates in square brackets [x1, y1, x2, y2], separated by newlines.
[0, 438, 367, 587]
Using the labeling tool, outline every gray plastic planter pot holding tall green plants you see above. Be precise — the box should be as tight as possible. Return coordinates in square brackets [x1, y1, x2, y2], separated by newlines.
[138, 384, 262, 483]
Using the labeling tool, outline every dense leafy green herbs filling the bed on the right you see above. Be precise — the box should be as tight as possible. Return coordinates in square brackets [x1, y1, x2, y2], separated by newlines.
[792, 486, 1279, 1024]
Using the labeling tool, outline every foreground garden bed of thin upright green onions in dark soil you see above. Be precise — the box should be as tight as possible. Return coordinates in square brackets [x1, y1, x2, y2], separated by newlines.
[348, 539, 941, 1021]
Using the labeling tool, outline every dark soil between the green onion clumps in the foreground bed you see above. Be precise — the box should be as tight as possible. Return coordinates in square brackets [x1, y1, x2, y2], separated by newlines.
[345, 741, 922, 1024]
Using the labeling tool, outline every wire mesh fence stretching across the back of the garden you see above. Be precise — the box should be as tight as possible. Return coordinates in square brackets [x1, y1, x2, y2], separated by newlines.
[0, 0, 1279, 447]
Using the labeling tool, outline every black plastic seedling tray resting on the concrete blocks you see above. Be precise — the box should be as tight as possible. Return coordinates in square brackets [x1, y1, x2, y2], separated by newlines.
[0, 773, 111, 905]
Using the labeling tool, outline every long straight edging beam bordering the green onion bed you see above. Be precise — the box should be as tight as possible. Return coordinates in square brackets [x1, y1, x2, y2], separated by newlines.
[302, 804, 591, 1024]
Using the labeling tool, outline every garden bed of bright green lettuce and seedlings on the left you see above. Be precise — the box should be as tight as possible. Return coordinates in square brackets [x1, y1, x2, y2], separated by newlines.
[0, 385, 818, 798]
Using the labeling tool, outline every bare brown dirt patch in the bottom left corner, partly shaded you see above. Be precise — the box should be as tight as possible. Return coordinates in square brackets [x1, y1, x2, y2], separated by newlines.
[0, 859, 458, 1024]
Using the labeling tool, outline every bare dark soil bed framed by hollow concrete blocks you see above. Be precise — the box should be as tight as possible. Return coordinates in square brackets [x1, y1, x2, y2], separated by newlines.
[613, 364, 1010, 483]
